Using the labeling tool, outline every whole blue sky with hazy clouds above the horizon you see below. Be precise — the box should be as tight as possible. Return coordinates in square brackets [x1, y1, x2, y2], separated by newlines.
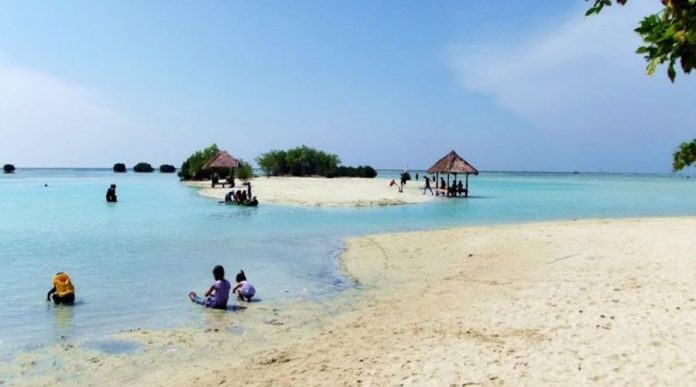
[0, 0, 696, 173]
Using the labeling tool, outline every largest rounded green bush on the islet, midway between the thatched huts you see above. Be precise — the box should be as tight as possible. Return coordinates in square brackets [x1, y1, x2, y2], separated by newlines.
[256, 145, 341, 176]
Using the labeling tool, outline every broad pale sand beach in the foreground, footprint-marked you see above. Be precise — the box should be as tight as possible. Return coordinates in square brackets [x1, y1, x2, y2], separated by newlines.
[5, 217, 696, 386]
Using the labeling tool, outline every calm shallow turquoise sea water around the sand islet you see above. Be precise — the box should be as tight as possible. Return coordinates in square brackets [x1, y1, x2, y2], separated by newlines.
[0, 169, 696, 357]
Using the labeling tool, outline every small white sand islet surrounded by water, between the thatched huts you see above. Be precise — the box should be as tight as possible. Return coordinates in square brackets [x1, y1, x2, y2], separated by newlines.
[186, 177, 433, 207]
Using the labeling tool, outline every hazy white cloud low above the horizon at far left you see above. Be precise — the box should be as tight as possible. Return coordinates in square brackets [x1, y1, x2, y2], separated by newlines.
[0, 62, 142, 166]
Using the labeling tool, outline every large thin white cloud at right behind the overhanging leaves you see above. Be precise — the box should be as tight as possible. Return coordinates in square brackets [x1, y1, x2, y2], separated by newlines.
[449, 2, 696, 170]
